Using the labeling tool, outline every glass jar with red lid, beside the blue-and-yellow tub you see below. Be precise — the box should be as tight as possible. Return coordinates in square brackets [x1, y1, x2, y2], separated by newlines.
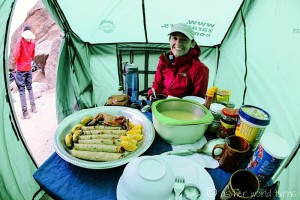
[217, 108, 239, 138]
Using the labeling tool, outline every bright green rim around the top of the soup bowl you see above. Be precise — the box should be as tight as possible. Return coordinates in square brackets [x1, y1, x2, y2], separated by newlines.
[151, 99, 214, 126]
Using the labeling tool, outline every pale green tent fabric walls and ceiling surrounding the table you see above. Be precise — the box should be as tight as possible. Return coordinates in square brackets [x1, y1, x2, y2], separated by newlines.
[0, 0, 300, 200]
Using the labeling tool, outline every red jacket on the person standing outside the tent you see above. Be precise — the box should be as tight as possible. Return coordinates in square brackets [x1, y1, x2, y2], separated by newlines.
[14, 37, 35, 72]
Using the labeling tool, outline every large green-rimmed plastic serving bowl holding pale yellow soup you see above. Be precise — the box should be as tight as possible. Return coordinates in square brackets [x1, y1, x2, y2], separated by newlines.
[151, 99, 213, 145]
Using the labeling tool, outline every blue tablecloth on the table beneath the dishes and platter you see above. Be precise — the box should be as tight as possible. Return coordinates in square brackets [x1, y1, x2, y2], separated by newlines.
[33, 132, 231, 200]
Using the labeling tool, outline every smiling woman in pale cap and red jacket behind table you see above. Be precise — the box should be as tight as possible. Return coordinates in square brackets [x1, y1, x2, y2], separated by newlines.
[148, 23, 209, 98]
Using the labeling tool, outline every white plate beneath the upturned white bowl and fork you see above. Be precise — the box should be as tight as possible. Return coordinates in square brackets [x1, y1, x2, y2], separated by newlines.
[117, 155, 216, 200]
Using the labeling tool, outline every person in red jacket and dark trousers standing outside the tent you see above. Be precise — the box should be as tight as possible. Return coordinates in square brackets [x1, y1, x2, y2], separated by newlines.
[14, 26, 37, 119]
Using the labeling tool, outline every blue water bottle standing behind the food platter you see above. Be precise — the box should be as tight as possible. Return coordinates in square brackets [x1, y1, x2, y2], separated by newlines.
[125, 63, 139, 103]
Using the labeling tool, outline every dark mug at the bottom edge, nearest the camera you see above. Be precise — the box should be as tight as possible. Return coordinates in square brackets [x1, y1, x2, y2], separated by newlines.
[217, 169, 260, 200]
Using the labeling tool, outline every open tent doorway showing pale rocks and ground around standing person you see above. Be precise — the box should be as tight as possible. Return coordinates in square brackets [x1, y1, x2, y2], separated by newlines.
[9, 0, 62, 166]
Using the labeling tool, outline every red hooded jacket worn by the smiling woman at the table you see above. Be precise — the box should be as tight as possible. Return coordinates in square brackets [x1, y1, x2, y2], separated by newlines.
[148, 45, 209, 98]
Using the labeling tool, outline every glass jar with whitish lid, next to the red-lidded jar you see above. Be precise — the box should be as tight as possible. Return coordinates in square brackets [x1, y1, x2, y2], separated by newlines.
[207, 103, 225, 135]
